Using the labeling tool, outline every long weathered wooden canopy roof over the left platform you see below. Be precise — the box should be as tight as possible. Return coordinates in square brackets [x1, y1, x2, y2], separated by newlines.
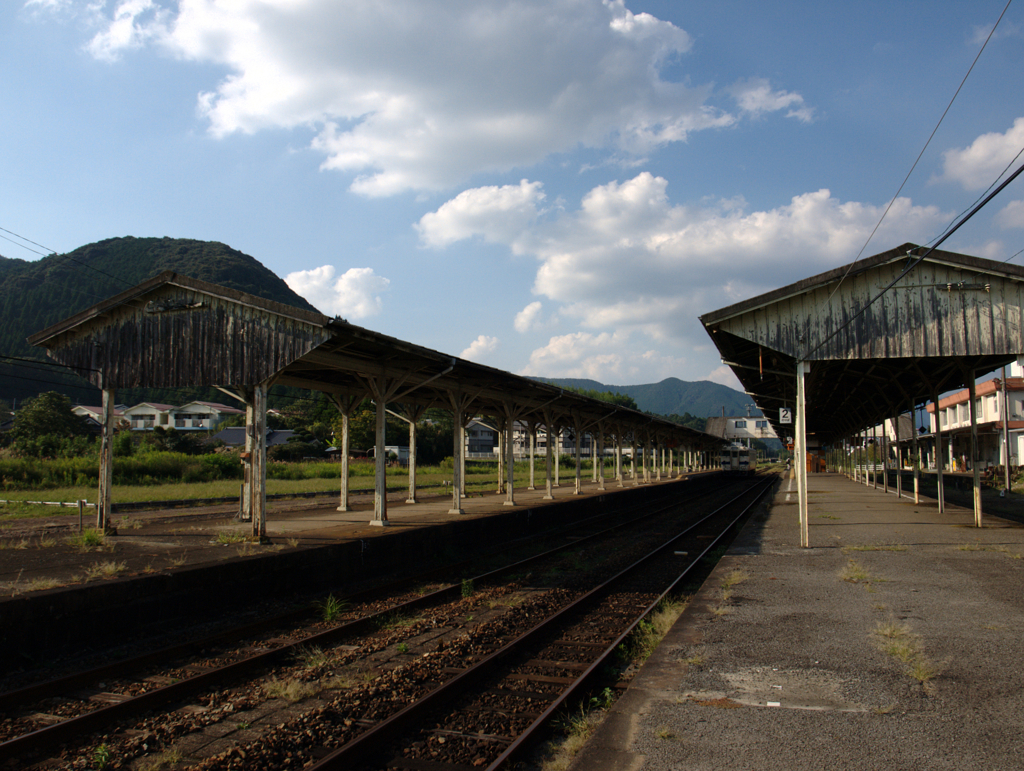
[29, 272, 721, 449]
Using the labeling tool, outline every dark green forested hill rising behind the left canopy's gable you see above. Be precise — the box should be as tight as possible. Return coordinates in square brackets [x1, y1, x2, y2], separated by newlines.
[0, 235, 315, 403]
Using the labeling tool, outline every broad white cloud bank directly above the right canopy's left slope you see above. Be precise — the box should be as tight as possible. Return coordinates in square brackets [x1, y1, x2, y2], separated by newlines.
[428, 172, 951, 379]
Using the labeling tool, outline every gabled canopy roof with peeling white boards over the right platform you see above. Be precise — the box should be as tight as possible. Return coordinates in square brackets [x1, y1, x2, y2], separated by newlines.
[700, 244, 1024, 444]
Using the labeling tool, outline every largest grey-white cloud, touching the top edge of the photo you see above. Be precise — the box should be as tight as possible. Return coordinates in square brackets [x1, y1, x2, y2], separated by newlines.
[75, 0, 753, 196]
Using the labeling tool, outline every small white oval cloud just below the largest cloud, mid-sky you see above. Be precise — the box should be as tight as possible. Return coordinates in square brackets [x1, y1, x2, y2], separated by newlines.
[416, 179, 544, 247]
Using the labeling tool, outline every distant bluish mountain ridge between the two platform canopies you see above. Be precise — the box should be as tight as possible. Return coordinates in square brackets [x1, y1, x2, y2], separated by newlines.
[538, 378, 761, 418]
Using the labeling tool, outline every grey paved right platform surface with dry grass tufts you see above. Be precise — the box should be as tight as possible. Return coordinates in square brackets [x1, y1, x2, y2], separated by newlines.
[571, 474, 1024, 771]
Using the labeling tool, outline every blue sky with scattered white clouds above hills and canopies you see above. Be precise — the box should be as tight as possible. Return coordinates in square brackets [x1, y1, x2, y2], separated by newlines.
[0, 0, 1024, 388]
